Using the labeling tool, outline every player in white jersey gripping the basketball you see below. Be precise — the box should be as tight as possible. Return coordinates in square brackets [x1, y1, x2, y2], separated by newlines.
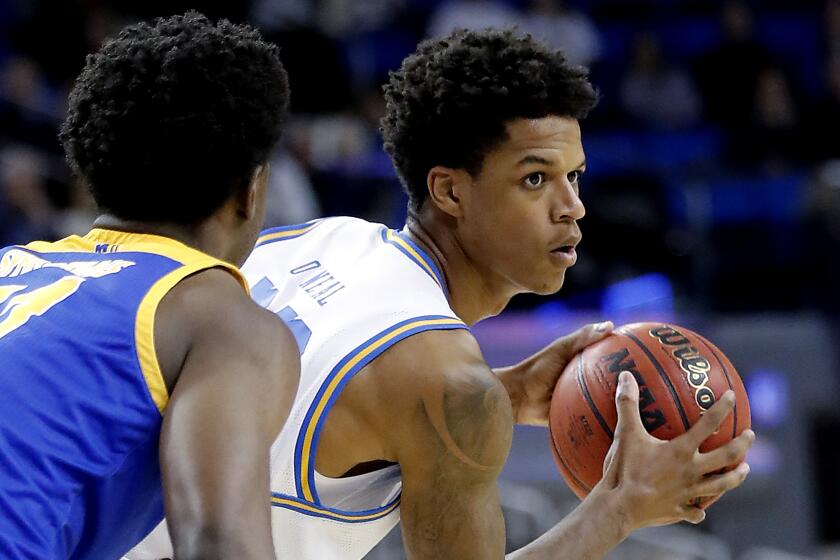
[132, 31, 754, 560]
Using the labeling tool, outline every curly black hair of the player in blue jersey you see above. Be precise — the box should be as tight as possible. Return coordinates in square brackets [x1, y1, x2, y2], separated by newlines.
[59, 12, 289, 224]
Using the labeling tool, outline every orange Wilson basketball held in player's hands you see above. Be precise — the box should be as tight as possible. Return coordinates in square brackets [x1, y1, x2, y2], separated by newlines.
[549, 323, 750, 507]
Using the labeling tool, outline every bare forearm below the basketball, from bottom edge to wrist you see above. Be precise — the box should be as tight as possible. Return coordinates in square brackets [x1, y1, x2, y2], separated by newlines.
[505, 487, 629, 560]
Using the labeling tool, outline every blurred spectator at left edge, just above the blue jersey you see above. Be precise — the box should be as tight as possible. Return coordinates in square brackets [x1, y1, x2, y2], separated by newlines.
[0, 146, 55, 246]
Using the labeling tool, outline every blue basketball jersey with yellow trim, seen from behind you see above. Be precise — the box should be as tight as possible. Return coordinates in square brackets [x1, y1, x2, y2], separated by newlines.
[0, 229, 247, 560]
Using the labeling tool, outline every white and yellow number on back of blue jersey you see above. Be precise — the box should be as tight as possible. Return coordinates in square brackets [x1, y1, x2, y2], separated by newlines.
[0, 276, 85, 338]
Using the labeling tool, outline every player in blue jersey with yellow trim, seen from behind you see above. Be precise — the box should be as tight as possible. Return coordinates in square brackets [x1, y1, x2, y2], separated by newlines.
[0, 12, 299, 560]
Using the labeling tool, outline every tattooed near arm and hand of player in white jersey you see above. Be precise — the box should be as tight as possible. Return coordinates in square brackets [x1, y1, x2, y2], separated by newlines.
[380, 331, 754, 560]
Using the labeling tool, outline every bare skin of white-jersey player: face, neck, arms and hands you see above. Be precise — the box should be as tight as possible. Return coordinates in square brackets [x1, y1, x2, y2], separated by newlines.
[316, 117, 754, 560]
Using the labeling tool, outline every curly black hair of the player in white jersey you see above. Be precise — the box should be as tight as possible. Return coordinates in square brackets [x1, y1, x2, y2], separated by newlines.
[380, 29, 598, 210]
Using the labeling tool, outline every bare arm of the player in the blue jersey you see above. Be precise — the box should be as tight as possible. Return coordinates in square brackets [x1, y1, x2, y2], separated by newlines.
[155, 270, 300, 559]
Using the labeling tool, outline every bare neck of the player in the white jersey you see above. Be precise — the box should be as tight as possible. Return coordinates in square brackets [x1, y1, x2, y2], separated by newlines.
[406, 209, 516, 325]
